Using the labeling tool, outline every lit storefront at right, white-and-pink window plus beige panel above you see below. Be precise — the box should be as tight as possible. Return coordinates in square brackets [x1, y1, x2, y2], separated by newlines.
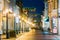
[51, 9, 58, 34]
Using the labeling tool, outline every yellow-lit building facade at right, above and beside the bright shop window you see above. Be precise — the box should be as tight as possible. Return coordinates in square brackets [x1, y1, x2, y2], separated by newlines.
[48, 0, 58, 32]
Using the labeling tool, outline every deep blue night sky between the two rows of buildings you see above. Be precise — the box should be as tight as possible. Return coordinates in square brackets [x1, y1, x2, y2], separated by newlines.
[16, 0, 44, 14]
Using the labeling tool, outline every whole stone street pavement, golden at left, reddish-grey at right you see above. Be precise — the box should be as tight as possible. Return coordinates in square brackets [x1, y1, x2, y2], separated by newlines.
[2, 30, 60, 40]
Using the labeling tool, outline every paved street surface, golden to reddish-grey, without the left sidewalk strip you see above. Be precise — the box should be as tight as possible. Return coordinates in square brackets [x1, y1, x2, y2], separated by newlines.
[16, 30, 60, 40]
